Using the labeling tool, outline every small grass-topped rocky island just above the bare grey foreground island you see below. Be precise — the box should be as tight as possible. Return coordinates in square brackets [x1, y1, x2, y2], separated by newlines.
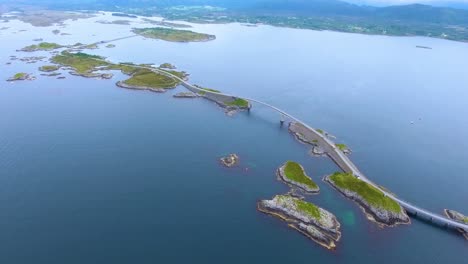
[277, 161, 320, 194]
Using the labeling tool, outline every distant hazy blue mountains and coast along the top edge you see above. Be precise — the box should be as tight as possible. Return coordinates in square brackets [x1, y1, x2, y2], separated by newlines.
[0, 0, 468, 41]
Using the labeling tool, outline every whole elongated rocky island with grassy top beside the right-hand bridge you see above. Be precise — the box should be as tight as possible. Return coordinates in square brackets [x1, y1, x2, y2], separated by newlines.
[324, 172, 411, 226]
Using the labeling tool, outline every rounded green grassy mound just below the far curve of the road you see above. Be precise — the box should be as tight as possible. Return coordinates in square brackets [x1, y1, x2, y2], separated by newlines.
[123, 69, 179, 89]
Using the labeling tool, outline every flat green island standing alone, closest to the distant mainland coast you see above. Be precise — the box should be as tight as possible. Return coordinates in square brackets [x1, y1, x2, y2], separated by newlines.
[132, 27, 215, 42]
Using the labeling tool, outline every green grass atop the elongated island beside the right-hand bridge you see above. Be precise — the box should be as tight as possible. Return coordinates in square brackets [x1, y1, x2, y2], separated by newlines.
[330, 172, 402, 213]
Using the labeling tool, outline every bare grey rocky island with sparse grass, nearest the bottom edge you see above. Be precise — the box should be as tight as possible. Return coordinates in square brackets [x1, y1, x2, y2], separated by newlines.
[257, 195, 341, 249]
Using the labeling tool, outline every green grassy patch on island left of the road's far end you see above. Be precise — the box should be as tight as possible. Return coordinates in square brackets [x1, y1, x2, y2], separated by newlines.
[51, 51, 110, 74]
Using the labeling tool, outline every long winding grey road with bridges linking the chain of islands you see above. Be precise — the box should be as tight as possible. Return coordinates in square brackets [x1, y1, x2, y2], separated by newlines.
[88, 35, 468, 232]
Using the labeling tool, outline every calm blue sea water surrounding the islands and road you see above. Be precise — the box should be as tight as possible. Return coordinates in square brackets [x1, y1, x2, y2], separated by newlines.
[0, 12, 468, 264]
